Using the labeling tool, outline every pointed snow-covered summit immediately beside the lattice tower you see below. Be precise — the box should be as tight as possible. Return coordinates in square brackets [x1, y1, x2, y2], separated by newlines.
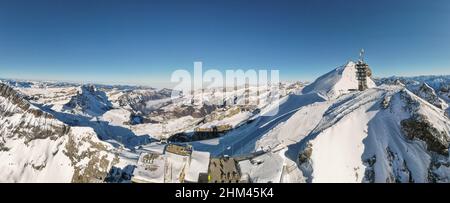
[303, 61, 376, 98]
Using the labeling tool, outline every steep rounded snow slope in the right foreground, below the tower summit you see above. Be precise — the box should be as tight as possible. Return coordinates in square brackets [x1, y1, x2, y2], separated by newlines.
[300, 86, 450, 182]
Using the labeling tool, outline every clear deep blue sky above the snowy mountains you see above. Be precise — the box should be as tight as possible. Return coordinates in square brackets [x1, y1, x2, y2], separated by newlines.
[0, 0, 450, 85]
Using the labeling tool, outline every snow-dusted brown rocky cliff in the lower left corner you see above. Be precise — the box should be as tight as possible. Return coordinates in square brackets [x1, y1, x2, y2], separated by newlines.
[0, 84, 118, 182]
